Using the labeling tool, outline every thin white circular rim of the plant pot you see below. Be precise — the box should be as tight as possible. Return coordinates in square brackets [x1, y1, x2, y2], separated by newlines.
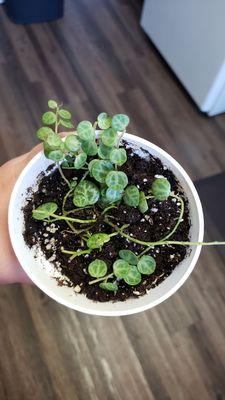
[8, 133, 204, 316]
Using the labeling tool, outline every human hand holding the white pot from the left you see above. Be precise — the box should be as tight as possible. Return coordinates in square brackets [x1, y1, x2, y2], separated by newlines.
[0, 145, 41, 284]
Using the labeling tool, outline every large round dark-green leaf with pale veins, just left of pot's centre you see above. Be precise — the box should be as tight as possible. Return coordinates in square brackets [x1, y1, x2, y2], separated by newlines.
[73, 180, 100, 207]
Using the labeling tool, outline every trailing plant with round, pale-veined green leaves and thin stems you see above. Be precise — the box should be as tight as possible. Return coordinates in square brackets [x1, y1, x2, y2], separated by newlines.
[32, 100, 225, 292]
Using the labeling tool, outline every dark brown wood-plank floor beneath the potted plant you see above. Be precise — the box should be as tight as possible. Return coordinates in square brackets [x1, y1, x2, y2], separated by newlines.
[0, 0, 225, 400]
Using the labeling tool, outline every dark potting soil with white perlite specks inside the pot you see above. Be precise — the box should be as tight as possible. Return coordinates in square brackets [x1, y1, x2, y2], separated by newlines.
[23, 142, 190, 302]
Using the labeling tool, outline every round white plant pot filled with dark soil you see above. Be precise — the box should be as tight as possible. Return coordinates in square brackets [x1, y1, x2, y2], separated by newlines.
[9, 133, 204, 316]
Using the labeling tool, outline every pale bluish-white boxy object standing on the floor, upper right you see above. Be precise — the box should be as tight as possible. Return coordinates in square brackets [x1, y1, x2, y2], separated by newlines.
[141, 0, 225, 112]
